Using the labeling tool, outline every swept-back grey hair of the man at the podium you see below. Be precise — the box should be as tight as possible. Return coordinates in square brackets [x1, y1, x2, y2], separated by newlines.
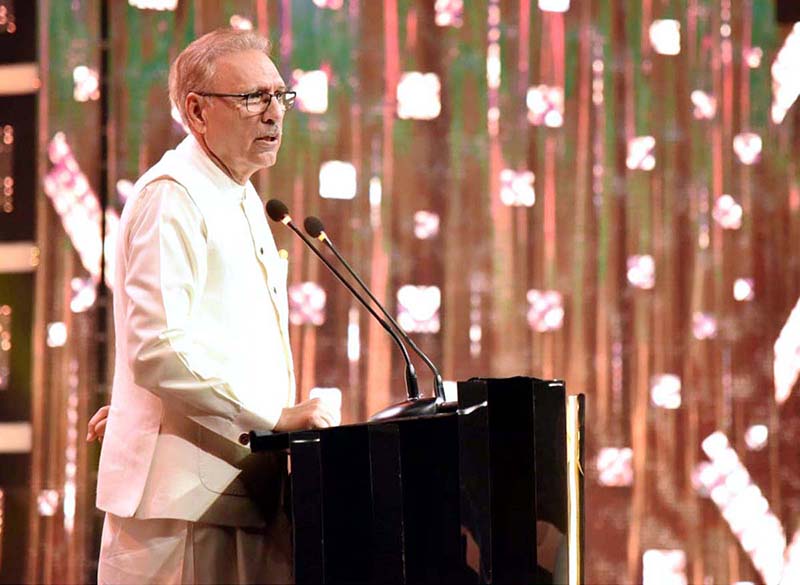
[169, 28, 270, 125]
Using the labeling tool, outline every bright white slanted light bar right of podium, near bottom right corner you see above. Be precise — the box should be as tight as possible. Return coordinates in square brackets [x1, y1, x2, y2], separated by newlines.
[701, 431, 786, 583]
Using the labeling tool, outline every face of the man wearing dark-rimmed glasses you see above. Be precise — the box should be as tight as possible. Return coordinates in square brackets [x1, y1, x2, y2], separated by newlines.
[195, 50, 286, 183]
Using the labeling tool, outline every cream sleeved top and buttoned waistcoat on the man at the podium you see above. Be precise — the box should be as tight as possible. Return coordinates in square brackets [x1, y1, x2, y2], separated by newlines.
[97, 137, 295, 580]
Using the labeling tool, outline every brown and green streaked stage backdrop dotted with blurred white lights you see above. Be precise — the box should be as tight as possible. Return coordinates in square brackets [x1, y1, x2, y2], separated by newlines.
[12, 0, 800, 583]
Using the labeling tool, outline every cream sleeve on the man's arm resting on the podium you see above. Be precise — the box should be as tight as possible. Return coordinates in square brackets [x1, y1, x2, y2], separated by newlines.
[120, 180, 281, 442]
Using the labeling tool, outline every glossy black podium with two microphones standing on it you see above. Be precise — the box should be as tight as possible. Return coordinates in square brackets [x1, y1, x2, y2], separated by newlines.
[250, 377, 583, 583]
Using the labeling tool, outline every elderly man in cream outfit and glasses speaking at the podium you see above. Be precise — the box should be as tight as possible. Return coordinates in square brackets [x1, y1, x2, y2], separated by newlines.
[97, 29, 339, 583]
